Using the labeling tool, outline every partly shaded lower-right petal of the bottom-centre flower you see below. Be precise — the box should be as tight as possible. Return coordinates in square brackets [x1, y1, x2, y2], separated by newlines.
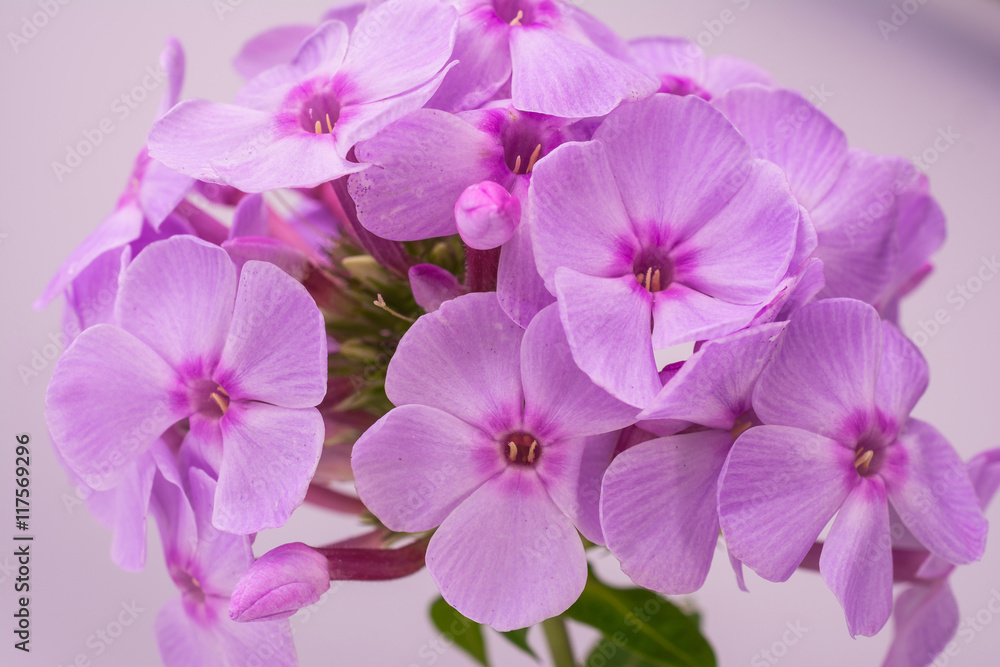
[535, 431, 620, 544]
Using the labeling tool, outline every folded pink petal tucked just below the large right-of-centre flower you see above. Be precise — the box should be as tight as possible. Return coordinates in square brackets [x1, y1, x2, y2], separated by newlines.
[640, 323, 785, 432]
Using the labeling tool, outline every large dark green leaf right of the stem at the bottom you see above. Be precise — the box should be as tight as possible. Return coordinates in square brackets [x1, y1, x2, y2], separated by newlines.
[566, 571, 716, 667]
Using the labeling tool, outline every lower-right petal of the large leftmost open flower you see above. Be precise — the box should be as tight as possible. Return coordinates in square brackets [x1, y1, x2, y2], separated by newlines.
[212, 401, 324, 534]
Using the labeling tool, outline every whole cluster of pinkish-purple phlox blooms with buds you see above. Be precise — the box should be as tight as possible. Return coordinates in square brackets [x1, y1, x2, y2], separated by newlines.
[39, 0, 1000, 667]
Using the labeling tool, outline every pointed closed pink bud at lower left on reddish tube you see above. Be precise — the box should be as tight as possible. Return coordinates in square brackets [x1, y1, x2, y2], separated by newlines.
[229, 542, 330, 622]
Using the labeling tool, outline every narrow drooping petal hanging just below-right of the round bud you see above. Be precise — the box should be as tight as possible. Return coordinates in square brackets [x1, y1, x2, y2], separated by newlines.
[497, 213, 556, 327]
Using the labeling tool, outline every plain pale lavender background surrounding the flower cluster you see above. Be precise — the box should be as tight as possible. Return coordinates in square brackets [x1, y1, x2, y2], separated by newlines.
[0, 0, 1000, 667]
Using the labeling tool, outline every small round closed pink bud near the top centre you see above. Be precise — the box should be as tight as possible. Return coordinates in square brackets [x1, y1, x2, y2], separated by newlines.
[455, 181, 521, 250]
